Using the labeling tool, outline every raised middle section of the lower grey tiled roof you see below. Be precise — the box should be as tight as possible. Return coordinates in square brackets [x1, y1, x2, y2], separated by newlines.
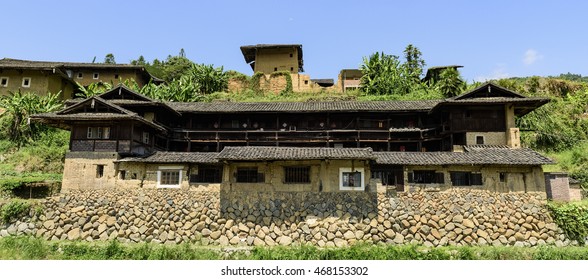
[218, 147, 375, 161]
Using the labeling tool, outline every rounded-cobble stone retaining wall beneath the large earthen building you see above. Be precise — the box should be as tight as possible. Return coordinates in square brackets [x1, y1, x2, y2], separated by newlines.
[0, 189, 573, 246]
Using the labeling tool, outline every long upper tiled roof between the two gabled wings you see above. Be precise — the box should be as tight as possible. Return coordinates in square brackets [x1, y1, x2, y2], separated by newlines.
[167, 100, 440, 113]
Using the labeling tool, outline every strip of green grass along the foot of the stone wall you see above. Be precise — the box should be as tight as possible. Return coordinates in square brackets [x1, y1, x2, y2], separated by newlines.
[0, 236, 588, 260]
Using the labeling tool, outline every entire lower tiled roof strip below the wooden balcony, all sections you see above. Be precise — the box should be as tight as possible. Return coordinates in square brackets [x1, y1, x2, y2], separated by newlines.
[113, 147, 553, 165]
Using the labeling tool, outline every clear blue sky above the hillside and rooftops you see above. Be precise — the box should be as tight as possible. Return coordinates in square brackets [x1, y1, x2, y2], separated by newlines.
[0, 0, 588, 82]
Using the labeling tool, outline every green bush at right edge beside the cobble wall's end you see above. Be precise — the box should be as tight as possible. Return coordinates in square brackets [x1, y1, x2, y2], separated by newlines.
[547, 202, 588, 245]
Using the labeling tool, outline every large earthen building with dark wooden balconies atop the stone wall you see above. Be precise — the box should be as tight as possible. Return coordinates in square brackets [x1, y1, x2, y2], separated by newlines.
[32, 82, 552, 192]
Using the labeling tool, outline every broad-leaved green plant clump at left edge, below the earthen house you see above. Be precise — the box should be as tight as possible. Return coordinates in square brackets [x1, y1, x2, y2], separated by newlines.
[0, 90, 63, 146]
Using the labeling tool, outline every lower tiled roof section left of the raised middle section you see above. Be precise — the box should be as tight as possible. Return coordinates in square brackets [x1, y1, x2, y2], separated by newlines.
[117, 152, 218, 163]
